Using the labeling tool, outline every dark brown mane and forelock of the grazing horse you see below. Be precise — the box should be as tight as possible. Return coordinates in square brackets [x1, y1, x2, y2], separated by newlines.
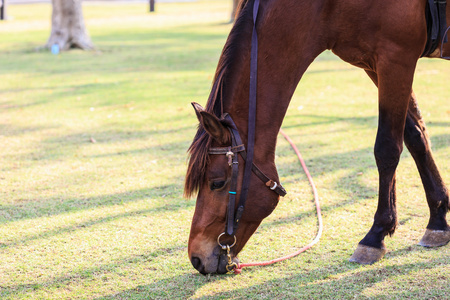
[184, 0, 253, 198]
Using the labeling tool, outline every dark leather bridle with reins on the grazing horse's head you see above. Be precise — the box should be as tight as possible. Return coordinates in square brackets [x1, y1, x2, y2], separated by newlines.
[208, 0, 286, 271]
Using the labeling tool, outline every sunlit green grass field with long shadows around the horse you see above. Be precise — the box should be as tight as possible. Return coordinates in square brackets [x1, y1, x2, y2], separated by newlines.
[0, 0, 450, 299]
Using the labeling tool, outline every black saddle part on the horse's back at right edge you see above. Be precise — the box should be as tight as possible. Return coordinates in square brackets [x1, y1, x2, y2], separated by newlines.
[421, 0, 448, 57]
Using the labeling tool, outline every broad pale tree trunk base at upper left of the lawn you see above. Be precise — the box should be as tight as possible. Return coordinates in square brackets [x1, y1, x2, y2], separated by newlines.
[45, 0, 94, 50]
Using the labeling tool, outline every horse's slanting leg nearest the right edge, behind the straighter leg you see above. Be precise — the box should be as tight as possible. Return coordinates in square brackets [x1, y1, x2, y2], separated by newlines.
[404, 93, 450, 247]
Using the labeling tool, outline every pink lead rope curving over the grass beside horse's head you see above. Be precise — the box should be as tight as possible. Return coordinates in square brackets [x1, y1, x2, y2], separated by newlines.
[234, 129, 323, 274]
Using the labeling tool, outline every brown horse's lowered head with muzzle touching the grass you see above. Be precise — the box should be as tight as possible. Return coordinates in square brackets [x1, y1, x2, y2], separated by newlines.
[185, 103, 279, 274]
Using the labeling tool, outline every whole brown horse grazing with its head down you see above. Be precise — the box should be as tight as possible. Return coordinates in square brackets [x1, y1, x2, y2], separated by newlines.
[185, 0, 450, 274]
